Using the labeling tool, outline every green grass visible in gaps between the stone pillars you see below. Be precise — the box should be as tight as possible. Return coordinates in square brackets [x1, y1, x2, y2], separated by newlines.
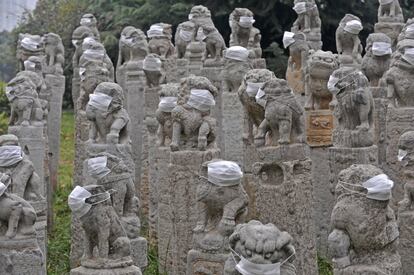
[47, 112, 333, 275]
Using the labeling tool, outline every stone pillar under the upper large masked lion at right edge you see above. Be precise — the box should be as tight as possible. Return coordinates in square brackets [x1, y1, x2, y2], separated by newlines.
[385, 107, 414, 202]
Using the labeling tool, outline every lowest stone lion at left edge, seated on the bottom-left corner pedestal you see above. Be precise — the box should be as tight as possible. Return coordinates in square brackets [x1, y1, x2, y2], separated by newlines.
[0, 172, 36, 240]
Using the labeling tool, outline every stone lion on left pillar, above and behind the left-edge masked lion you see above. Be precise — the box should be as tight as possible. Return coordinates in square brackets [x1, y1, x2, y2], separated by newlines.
[6, 74, 43, 126]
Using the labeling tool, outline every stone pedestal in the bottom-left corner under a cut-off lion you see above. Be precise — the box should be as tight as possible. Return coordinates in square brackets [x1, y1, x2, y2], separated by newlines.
[0, 238, 47, 275]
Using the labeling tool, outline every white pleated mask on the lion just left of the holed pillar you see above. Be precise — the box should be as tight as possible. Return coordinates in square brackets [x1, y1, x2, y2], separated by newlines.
[207, 160, 243, 186]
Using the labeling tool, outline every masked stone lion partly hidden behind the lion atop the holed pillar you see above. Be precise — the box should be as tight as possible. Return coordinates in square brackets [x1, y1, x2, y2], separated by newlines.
[238, 69, 276, 144]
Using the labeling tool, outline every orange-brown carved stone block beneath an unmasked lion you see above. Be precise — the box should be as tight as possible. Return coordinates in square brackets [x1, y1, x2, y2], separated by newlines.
[306, 110, 334, 147]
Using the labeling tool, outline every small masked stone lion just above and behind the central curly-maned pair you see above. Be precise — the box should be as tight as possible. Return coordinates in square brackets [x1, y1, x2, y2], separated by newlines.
[143, 53, 167, 87]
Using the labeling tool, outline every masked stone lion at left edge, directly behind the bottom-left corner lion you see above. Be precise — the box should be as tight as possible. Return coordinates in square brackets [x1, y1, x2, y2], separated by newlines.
[0, 134, 44, 202]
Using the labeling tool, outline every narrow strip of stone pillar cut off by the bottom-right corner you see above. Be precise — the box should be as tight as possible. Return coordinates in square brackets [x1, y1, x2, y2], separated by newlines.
[398, 211, 414, 275]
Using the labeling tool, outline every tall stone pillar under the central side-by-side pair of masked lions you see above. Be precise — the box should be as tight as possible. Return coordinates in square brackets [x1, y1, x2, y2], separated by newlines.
[158, 149, 220, 275]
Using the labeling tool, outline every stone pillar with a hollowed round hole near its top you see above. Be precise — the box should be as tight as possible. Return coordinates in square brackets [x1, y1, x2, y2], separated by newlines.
[254, 144, 318, 274]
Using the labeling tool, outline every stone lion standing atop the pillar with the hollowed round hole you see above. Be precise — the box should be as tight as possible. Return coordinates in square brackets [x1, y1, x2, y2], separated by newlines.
[254, 78, 305, 147]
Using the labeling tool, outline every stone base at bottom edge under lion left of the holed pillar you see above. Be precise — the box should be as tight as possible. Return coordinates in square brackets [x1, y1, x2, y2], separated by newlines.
[186, 249, 229, 275]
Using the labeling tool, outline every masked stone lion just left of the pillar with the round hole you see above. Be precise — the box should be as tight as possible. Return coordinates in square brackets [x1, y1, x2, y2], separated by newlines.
[193, 160, 248, 252]
